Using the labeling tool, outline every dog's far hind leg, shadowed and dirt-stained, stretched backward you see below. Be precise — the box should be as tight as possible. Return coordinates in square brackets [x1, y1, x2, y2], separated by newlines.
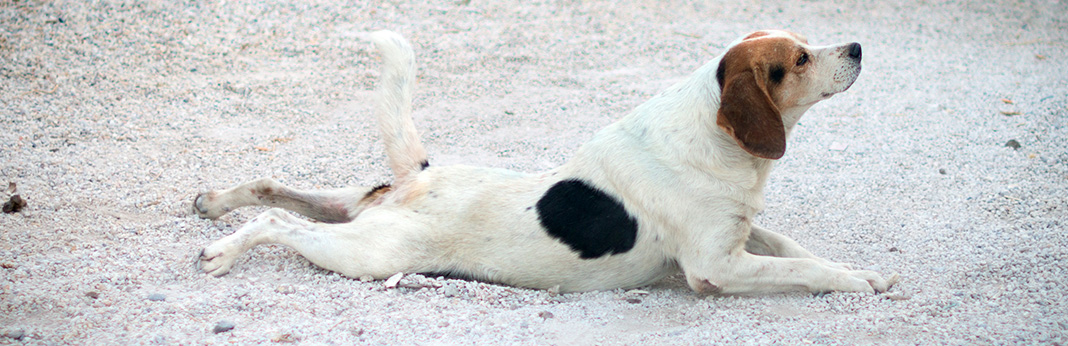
[193, 177, 388, 223]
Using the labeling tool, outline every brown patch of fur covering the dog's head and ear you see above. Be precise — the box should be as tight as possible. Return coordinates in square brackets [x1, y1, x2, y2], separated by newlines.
[716, 33, 799, 159]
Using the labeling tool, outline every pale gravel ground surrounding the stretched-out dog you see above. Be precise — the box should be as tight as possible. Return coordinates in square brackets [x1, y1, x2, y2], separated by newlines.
[0, 0, 1068, 345]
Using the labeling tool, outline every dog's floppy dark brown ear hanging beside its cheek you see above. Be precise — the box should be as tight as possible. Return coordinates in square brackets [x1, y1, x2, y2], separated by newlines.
[716, 69, 786, 160]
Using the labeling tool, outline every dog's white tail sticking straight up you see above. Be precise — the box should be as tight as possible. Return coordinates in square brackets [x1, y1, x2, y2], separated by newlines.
[371, 30, 429, 185]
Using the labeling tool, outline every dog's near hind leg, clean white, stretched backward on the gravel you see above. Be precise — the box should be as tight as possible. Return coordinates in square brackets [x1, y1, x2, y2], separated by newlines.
[200, 208, 435, 279]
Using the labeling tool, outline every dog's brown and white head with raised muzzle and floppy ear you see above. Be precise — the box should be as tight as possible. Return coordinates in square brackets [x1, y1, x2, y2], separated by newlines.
[716, 31, 861, 159]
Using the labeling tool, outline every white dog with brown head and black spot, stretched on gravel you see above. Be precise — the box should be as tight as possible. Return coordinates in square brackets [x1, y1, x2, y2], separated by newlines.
[192, 30, 898, 295]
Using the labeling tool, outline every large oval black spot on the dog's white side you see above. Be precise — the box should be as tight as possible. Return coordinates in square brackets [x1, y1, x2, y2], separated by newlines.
[537, 179, 638, 260]
